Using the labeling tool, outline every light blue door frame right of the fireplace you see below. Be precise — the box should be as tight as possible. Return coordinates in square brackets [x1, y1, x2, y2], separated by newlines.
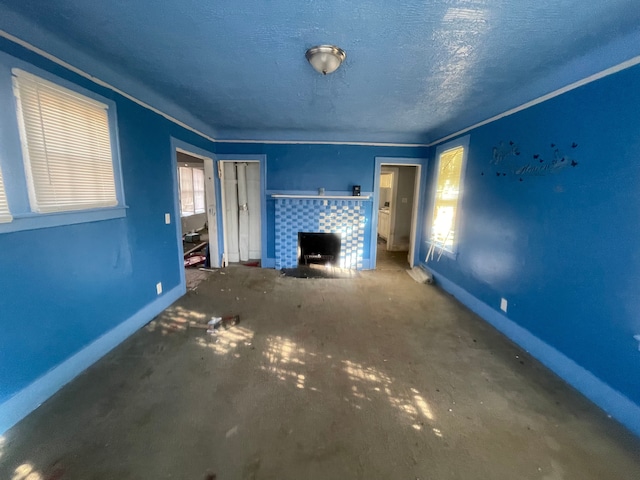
[369, 157, 428, 269]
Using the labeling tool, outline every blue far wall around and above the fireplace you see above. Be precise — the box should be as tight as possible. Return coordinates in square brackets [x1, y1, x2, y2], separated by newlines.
[216, 143, 427, 263]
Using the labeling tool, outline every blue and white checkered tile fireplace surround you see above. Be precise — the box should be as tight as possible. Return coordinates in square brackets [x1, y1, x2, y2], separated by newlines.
[275, 197, 367, 270]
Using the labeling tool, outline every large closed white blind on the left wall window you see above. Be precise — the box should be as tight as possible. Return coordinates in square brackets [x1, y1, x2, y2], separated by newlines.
[13, 69, 118, 213]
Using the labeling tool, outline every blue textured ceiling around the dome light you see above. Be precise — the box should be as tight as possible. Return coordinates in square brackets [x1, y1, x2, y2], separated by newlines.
[0, 0, 640, 143]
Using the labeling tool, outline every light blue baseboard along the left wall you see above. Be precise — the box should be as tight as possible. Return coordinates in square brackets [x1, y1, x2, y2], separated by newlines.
[0, 284, 186, 435]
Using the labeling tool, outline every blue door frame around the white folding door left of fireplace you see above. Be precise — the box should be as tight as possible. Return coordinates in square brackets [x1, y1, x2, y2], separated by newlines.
[214, 153, 268, 268]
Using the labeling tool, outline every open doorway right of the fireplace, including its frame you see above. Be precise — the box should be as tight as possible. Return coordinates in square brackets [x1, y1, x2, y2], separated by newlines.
[371, 157, 422, 270]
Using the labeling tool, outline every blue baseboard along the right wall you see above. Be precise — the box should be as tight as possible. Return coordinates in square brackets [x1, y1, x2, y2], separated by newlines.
[420, 262, 640, 437]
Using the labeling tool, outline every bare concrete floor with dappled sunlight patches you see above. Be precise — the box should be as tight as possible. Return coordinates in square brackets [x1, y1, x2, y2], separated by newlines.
[0, 253, 640, 480]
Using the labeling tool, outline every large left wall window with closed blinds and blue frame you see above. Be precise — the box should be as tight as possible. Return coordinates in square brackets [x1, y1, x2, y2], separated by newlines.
[0, 54, 126, 233]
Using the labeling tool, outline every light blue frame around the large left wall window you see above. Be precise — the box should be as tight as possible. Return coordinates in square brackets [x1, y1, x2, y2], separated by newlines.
[0, 52, 127, 234]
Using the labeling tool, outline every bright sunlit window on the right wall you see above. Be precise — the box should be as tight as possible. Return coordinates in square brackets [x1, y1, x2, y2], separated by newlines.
[431, 139, 465, 252]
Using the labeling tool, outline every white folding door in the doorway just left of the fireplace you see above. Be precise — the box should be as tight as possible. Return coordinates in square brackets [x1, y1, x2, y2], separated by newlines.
[218, 160, 263, 267]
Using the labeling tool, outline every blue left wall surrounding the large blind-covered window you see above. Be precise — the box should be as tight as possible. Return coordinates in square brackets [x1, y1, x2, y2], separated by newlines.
[0, 37, 212, 420]
